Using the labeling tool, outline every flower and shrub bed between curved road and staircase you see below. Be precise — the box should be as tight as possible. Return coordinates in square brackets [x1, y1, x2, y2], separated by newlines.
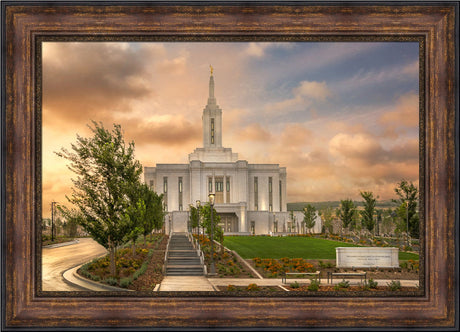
[78, 234, 168, 291]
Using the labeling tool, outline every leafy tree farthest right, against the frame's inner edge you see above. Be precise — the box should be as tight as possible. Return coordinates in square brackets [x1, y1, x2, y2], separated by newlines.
[392, 180, 420, 238]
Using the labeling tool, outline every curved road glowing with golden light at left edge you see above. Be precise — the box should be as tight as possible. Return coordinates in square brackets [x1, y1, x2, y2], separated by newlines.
[42, 238, 107, 291]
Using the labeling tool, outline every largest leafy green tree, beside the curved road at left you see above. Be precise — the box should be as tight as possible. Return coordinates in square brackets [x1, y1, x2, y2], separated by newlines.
[56, 121, 142, 275]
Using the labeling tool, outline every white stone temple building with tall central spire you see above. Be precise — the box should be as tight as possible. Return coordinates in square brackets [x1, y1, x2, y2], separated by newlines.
[144, 67, 321, 235]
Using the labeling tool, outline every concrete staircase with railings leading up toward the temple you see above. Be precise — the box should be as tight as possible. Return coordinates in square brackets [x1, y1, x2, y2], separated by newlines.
[165, 233, 204, 276]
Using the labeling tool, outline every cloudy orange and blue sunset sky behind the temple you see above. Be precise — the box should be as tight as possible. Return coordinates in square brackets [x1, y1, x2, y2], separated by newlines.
[42, 42, 419, 216]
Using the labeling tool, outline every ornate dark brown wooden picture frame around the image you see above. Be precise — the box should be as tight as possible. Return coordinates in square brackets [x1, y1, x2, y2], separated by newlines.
[2, 1, 458, 330]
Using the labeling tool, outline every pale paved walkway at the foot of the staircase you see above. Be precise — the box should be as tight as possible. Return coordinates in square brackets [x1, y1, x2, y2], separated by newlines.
[158, 276, 215, 292]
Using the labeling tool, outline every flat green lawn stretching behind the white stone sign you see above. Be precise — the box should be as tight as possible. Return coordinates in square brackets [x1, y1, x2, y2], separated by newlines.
[224, 236, 418, 260]
